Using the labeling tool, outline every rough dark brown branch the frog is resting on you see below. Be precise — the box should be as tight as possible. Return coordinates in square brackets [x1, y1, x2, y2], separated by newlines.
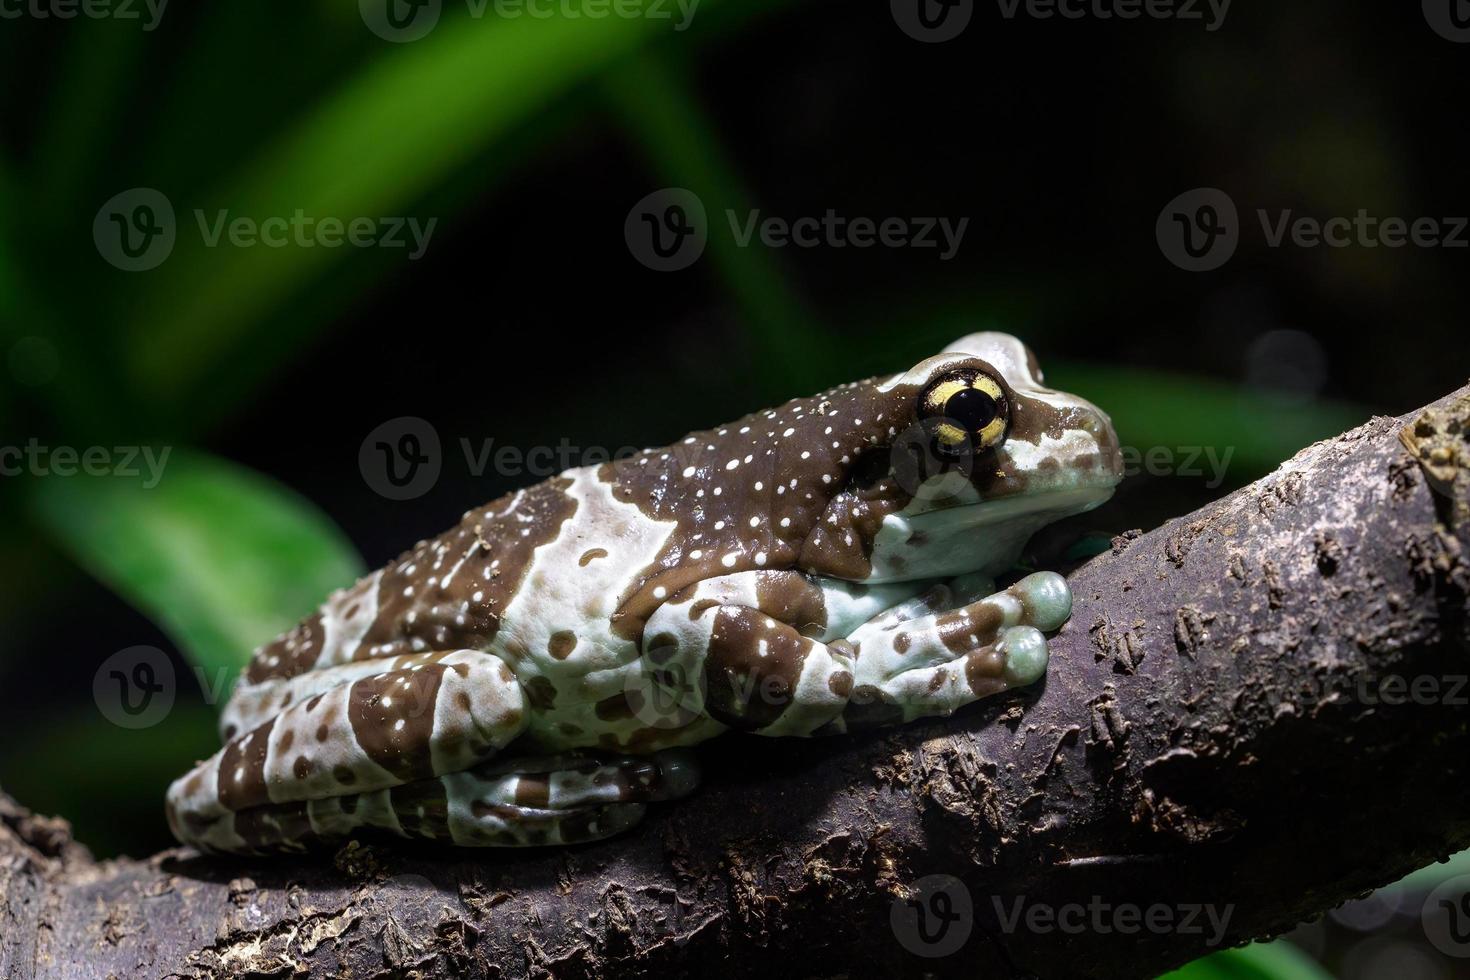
[0, 389, 1470, 980]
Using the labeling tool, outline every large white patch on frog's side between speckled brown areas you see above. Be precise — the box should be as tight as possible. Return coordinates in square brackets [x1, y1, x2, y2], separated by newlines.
[494, 467, 678, 680]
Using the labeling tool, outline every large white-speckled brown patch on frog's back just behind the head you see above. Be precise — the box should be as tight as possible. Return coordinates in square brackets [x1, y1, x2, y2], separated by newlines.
[598, 371, 919, 641]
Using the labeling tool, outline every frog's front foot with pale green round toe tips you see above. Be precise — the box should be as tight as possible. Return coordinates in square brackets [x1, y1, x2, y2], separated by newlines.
[842, 572, 1072, 729]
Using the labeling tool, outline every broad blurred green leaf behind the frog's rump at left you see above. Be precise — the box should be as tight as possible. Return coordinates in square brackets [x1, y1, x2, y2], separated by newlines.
[32, 450, 362, 671]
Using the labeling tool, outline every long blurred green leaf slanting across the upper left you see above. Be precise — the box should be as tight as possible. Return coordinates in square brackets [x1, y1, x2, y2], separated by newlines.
[129, 0, 717, 403]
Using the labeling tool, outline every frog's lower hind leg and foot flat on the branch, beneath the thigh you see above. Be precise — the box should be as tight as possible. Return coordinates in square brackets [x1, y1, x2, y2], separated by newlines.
[183, 749, 698, 852]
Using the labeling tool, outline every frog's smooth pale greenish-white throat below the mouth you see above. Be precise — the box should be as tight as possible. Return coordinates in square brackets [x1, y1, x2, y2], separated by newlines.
[866, 486, 1113, 583]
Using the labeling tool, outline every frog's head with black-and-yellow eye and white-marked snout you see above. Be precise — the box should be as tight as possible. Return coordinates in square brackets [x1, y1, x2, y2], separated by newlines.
[803, 334, 1123, 582]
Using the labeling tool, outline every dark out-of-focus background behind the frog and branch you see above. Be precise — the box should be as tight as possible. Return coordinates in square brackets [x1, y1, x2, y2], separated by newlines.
[0, 0, 1470, 976]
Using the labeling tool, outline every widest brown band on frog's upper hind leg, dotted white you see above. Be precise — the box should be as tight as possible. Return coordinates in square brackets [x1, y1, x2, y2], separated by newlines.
[347, 664, 444, 782]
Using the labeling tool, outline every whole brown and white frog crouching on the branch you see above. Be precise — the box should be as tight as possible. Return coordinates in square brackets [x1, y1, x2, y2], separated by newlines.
[166, 331, 1123, 855]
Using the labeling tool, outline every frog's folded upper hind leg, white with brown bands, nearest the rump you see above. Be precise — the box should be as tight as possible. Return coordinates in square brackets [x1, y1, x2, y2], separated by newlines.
[168, 649, 526, 851]
